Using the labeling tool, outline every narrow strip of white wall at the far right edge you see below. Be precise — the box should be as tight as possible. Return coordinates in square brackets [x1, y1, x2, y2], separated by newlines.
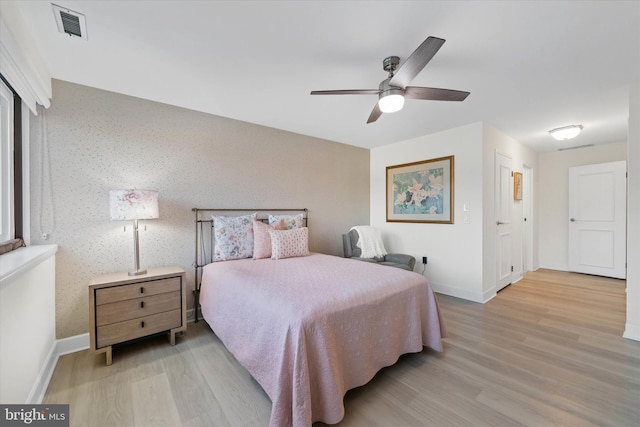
[624, 81, 640, 341]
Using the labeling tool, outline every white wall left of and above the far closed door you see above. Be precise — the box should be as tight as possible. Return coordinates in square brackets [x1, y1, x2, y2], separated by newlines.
[538, 142, 627, 271]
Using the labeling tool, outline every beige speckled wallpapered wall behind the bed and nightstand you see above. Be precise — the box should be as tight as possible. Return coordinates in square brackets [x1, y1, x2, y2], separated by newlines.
[30, 80, 369, 339]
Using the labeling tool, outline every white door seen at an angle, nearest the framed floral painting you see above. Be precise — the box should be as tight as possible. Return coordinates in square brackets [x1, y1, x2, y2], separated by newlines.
[494, 152, 513, 292]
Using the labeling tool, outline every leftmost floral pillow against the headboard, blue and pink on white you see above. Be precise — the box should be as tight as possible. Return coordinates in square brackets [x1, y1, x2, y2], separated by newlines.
[211, 213, 256, 261]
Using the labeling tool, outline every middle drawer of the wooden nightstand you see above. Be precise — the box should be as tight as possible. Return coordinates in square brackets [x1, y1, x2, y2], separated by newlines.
[96, 291, 182, 326]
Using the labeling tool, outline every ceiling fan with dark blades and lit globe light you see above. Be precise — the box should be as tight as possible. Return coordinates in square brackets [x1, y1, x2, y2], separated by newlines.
[311, 37, 469, 123]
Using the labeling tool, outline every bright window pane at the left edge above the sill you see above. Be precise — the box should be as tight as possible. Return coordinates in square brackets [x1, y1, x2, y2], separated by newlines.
[0, 79, 15, 243]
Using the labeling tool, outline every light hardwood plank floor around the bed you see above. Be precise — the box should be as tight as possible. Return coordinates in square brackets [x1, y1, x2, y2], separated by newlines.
[43, 270, 640, 427]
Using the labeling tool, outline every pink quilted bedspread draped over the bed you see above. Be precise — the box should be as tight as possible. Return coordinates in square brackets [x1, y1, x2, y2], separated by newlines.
[200, 253, 445, 427]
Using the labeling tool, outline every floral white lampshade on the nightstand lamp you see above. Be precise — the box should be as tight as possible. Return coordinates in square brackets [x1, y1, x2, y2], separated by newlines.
[109, 190, 158, 221]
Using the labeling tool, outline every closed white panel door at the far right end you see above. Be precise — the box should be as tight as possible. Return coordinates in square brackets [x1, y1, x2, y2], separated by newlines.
[568, 161, 627, 279]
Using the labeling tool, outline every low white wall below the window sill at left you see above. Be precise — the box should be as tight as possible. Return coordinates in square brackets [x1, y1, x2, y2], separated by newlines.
[0, 245, 57, 404]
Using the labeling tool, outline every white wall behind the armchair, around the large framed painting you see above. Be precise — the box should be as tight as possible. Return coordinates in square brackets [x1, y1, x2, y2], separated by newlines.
[370, 123, 483, 301]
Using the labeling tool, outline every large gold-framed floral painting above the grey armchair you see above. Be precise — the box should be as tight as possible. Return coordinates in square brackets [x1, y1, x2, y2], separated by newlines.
[386, 156, 454, 224]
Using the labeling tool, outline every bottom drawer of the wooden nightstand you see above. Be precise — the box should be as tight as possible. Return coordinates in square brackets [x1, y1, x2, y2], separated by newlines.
[97, 309, 182, 348]
